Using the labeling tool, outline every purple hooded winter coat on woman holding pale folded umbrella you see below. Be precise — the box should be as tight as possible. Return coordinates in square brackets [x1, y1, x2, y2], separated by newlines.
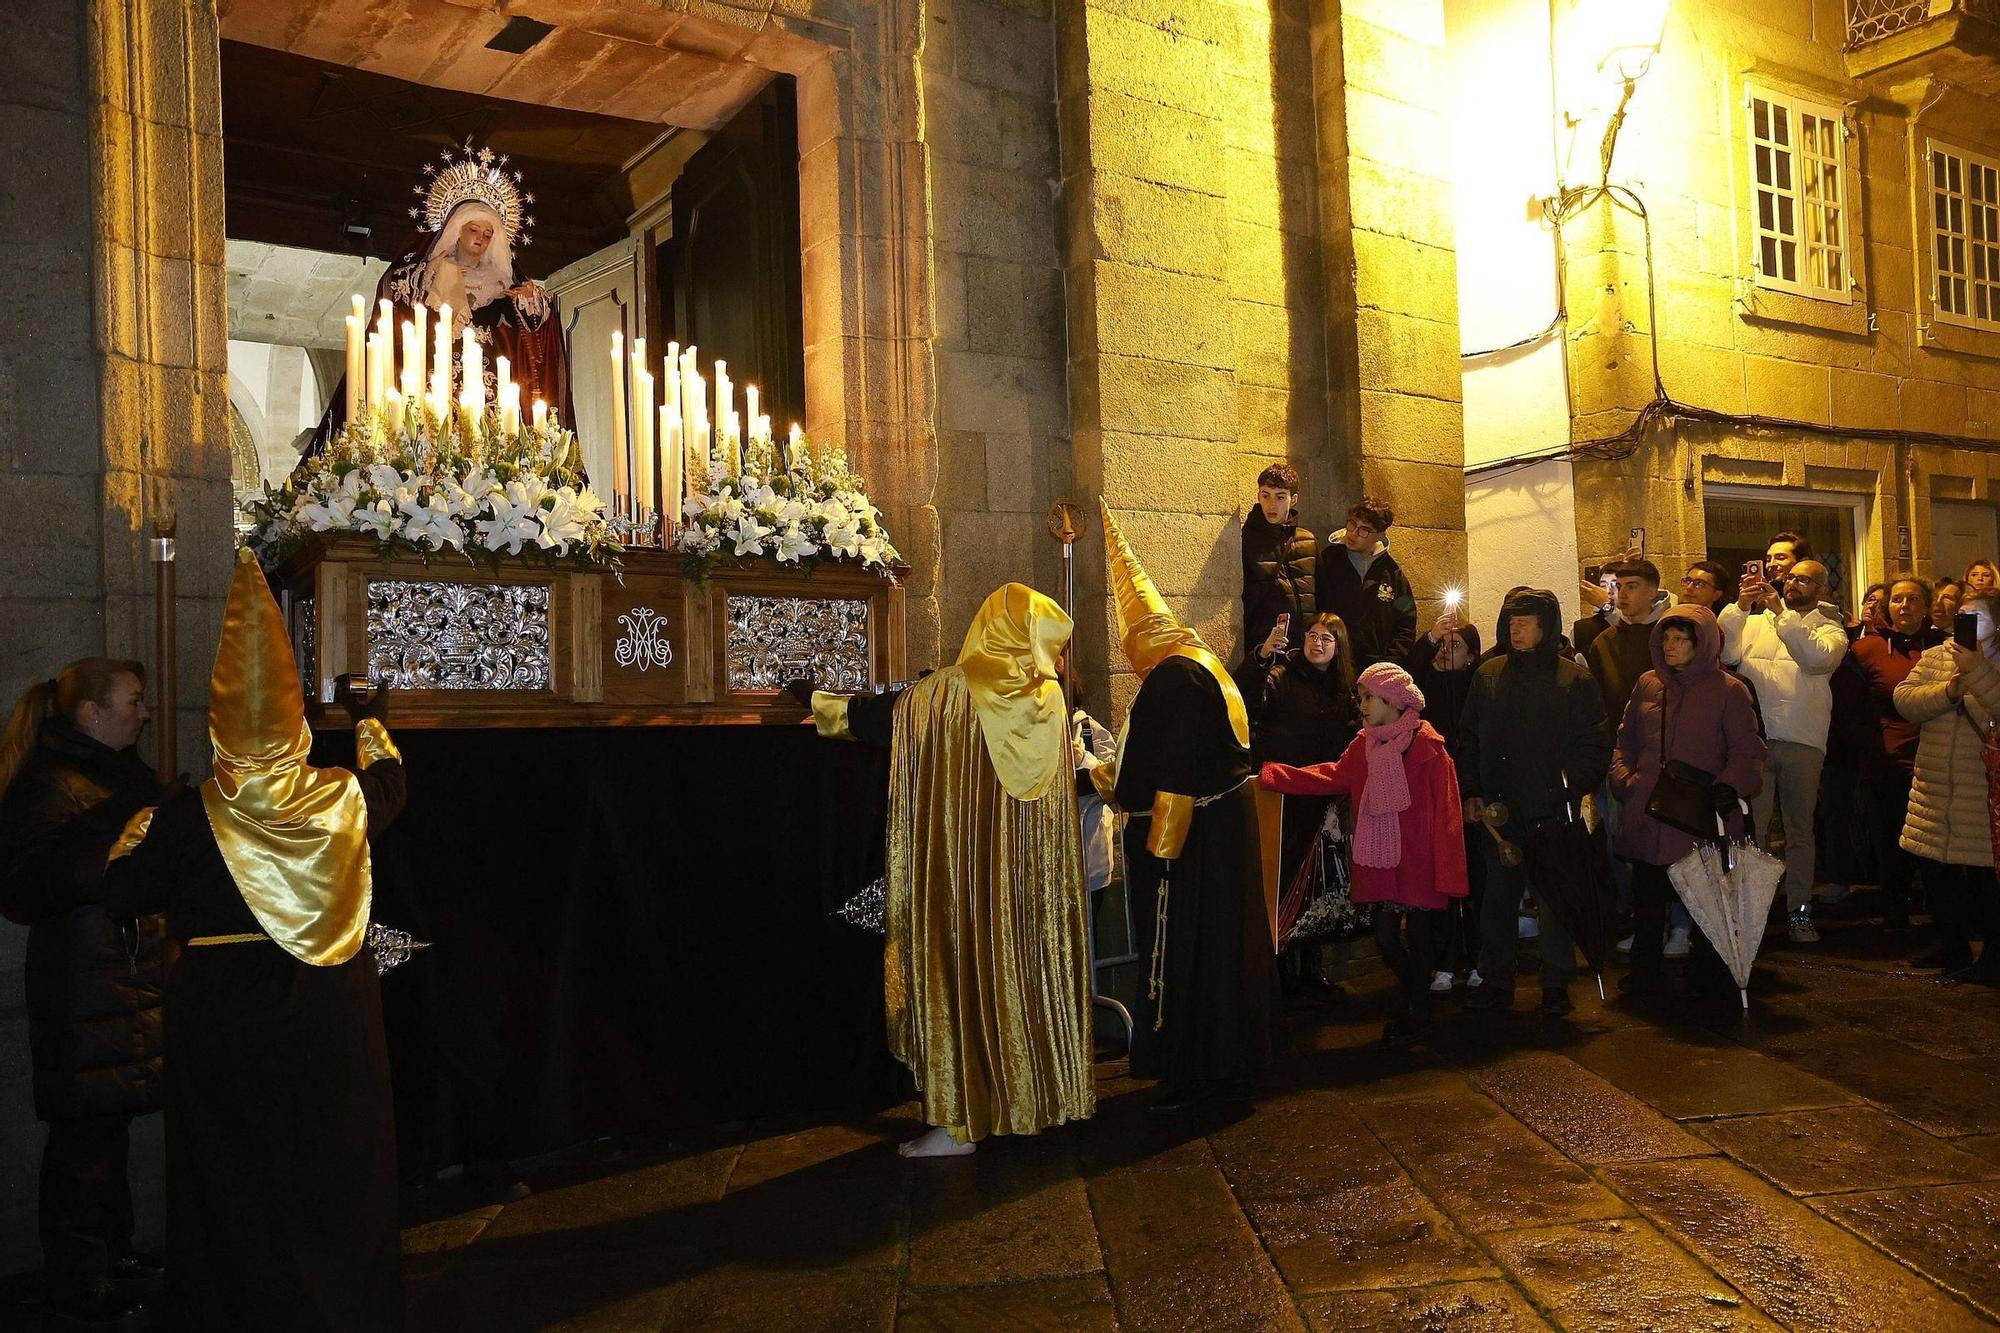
[1610, 606, 1764, 865]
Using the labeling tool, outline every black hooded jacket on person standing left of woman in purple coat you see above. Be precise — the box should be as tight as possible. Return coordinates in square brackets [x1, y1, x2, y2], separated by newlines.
[1452, 590, 1612, 829]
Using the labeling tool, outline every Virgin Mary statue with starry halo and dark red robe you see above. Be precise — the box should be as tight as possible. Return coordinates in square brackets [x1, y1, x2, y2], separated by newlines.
[312, 140, 576, 452]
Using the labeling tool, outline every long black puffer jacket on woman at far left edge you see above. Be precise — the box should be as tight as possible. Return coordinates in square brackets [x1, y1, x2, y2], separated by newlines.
[0, 721, 166, 1121]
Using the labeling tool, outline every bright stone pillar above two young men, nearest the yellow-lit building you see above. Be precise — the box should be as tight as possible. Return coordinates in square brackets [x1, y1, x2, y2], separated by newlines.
[1312, 0, 1466, 622]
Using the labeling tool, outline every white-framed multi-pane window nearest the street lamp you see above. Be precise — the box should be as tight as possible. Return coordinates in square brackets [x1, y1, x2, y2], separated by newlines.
[1744, 84, 1856, 304]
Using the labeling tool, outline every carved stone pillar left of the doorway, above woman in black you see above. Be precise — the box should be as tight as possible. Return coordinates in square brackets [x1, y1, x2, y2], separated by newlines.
[89, 0, 234, 773]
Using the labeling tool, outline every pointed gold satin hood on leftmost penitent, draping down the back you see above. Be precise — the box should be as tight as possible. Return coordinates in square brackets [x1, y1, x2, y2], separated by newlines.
[202, 550, 372, 967]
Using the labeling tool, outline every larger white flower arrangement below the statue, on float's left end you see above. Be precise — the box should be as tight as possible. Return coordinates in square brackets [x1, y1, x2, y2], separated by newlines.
[248, 408, 620, 566]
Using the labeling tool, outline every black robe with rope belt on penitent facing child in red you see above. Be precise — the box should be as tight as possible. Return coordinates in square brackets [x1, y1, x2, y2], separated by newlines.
[1118, 656, 1280, 1083]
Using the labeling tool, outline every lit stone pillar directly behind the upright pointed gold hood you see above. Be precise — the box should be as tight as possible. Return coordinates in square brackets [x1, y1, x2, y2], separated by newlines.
[1058, 0, 1238, 713]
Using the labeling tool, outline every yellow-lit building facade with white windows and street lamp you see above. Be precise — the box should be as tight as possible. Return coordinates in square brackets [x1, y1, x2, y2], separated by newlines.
[1448, 0, 2000, 608]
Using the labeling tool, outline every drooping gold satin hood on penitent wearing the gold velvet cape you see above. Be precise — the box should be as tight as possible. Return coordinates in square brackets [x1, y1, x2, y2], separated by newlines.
[958, 582, 1070, 801]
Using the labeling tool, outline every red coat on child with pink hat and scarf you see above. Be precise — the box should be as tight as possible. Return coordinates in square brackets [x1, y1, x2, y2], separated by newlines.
[1258, 723, 1466, 909]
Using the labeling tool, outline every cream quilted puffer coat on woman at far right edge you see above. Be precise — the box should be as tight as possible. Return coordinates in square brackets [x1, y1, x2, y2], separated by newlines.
[1896, 642, 2000, 865]
